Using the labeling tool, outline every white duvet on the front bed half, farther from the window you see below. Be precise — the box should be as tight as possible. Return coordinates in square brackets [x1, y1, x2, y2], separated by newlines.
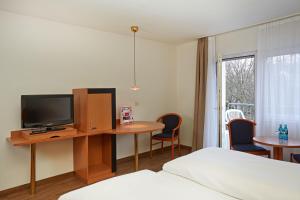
[59, 170, 236, 200]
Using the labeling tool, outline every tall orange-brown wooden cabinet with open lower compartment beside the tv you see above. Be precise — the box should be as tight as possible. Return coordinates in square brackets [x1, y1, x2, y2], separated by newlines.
[73, 89, 116, 184]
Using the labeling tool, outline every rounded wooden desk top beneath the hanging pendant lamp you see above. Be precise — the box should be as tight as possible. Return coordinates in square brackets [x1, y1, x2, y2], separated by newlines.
[109, 121, 165, 134]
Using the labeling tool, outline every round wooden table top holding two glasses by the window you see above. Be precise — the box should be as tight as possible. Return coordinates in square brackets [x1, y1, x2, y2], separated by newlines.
[253, 136, 300, 148]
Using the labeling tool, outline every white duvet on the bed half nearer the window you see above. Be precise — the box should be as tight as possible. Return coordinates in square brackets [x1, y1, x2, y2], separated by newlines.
[163, 148, 300, 200]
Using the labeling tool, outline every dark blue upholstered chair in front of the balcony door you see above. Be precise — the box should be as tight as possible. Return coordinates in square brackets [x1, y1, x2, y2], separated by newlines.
[228, 119, 271, 158]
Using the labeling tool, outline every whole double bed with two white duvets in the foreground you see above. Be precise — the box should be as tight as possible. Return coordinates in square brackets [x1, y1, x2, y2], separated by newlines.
[59, 148, 300, 200]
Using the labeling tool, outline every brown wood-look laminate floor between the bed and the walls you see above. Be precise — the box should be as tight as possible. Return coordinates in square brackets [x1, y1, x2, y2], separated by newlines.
[0, 148, 190, 200]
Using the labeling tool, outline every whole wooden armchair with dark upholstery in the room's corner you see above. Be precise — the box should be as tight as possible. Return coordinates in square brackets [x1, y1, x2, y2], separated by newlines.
[150, 113, 182, 159]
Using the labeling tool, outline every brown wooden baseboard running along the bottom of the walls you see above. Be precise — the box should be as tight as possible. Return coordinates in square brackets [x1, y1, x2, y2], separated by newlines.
[0, 145, 192, 197]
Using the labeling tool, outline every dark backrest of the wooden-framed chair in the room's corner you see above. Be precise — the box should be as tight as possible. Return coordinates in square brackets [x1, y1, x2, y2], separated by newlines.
[157, 113, 182, 133]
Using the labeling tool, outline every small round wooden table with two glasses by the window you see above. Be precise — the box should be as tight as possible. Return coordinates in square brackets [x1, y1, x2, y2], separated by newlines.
[253, 136, 300, 160]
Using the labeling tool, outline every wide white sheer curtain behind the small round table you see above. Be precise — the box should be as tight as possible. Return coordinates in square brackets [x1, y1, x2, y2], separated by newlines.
[256, 17, 300, 138]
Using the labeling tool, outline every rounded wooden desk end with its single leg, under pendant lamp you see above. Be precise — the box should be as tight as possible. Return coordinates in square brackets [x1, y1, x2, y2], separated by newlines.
[108, 121, 165, 171]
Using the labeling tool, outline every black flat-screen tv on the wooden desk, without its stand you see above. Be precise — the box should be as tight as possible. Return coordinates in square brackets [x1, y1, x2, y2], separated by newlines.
[21, 94, 74, 128]
